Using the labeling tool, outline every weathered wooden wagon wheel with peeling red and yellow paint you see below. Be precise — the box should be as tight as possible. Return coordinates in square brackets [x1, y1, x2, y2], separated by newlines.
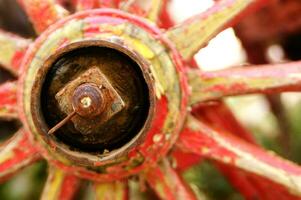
[0, 0, 301, 199]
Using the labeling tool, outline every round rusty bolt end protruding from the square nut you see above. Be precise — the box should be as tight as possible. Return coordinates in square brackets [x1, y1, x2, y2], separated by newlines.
[72, 83, 106, 118]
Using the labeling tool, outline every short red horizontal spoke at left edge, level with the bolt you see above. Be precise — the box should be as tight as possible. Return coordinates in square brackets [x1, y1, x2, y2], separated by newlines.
[0, 82, 18, 119]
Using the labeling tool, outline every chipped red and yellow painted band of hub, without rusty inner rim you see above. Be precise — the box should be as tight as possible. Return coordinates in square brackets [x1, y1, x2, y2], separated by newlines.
[22, 10, 186, 181]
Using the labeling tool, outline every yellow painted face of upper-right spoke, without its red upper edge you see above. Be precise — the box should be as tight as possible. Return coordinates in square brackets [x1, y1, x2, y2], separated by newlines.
[167, 0, 254, 59]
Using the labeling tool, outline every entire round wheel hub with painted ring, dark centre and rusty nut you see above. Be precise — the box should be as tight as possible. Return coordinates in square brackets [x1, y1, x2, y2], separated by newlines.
[19, 10, 187, 180]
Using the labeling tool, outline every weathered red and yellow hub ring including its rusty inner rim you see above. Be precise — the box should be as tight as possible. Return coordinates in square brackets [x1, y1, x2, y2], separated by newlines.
[20, 10, 187, 181]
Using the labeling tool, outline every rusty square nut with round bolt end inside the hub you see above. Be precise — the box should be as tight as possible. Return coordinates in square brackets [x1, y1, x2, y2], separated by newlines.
[55, 67, 125, 134]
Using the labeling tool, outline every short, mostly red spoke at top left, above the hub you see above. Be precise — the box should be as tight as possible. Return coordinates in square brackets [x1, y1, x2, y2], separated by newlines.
[18, 0, 68, 33]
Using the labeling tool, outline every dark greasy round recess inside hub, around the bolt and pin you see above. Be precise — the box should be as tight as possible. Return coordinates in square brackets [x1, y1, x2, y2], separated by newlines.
[41, 46, 150, 153]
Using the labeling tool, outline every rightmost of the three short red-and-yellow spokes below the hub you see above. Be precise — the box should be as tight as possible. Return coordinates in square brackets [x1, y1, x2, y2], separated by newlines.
[145, 160, 197, 200]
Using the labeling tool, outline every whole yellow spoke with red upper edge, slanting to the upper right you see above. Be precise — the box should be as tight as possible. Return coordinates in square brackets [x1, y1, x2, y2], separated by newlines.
[166, 0, 266, 60]
